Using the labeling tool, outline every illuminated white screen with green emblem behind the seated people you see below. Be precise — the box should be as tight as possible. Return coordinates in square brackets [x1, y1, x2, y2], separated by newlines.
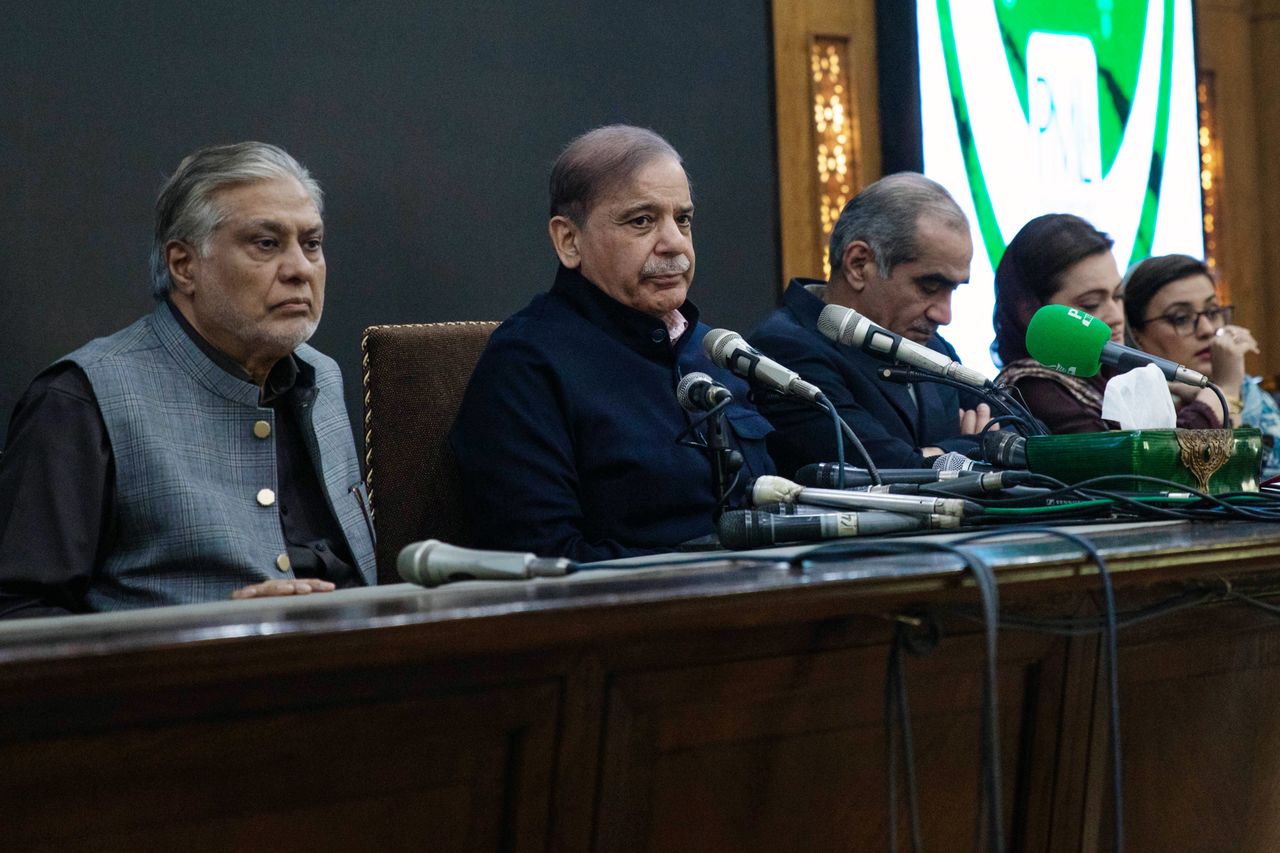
[916, 0, 1204, 373]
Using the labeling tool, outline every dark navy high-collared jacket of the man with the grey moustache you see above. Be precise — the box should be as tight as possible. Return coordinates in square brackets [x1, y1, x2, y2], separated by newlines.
[449, 266, 773, 561]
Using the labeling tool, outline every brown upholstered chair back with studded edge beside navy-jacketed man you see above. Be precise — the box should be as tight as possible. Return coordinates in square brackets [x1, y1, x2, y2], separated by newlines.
[361, 323, 498, 584]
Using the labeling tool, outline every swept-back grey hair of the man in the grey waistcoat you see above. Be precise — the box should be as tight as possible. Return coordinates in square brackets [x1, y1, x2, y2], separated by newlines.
[151, 142, 324, 301]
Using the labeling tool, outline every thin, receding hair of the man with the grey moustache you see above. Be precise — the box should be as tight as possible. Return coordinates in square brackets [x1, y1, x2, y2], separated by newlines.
[550, 124, 684, 225]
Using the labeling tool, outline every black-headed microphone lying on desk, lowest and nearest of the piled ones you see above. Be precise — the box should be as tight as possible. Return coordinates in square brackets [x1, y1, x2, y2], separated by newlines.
[718, 510, 960, 551]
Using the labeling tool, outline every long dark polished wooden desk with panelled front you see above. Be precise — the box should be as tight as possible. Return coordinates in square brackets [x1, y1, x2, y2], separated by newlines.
[0, 523, 1280, 852]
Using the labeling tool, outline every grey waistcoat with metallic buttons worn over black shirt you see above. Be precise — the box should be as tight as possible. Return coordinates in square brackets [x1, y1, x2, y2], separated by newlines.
[64, 302, 375, 611]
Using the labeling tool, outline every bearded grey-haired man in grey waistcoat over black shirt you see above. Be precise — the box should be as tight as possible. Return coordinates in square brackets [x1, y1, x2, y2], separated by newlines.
[0, 142, 374, 616]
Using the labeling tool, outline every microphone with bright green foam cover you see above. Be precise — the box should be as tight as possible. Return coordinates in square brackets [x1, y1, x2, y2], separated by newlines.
[1027, 305, 1211, 388]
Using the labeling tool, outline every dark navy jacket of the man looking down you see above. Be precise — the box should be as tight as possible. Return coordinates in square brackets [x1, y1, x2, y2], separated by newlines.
[750, 278, 978, 474]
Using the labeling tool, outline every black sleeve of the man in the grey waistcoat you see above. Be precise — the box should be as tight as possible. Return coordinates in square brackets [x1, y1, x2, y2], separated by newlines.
[0, 364, 114, 619]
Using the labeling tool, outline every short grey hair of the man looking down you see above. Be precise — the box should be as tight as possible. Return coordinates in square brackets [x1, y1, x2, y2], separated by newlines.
[828, 172, 969, 278]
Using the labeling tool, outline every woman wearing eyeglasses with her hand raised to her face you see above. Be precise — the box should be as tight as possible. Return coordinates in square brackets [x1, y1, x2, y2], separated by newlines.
[1124, 255, 1280, 476]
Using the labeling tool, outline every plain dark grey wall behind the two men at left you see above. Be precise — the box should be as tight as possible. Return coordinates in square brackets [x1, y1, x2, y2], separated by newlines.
[0, 0, 780, 443]
